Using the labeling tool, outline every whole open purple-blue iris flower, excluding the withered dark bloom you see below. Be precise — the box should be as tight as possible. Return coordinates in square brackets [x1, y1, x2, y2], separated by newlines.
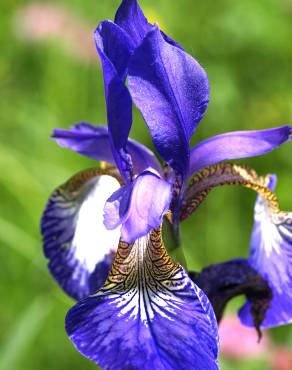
[41, 0, 292, 370]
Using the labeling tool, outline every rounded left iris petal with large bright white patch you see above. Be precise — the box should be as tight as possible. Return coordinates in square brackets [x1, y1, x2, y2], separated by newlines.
[41, 169, 120, 300]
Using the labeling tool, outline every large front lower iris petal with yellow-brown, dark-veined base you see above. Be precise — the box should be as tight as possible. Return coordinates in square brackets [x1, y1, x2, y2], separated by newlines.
[66, 230, 218, 370]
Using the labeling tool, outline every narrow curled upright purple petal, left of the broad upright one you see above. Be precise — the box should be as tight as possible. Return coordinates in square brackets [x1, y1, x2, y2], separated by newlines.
[94, 21, 133, 180]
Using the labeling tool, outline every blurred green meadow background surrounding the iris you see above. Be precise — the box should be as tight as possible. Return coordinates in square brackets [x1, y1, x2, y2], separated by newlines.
[0, 0, 292, 370]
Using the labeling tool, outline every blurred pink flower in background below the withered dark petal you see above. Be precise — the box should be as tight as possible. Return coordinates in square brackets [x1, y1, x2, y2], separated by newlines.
[219, 316, 270, 360]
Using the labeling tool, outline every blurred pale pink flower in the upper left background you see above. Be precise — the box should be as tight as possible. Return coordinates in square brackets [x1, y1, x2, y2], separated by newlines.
[15, 3, 97, 61]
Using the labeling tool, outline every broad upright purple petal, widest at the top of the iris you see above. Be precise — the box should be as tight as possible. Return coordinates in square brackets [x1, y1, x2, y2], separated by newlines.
[129, 26, 209, 175]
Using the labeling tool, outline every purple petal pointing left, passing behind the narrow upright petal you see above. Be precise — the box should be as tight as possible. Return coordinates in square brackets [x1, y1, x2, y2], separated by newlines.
[52, 123, 162, 174]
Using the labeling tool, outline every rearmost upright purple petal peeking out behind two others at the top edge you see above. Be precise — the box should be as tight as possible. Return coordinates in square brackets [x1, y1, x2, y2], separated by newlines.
[115, 0, 181, 48]
